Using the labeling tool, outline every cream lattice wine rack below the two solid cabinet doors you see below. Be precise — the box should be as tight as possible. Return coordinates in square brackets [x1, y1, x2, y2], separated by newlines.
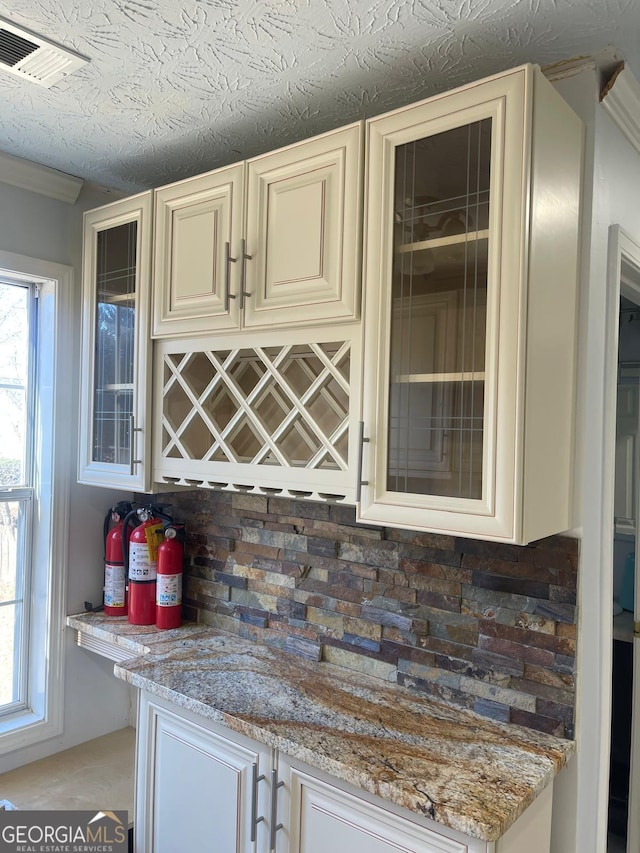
[155, 334, 359, 500]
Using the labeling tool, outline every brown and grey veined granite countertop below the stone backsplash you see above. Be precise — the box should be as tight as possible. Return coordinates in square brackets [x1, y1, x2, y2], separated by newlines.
[67, 614, 575, 841]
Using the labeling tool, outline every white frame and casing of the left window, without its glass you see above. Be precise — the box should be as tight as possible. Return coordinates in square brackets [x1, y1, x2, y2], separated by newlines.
[0, 251, 74, 755]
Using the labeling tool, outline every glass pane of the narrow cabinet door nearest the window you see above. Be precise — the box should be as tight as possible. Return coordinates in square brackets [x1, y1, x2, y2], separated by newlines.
[92, 222, 137, 465]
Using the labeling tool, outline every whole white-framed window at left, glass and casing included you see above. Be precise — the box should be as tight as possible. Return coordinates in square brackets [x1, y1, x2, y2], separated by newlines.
[0, 252, 72, 753]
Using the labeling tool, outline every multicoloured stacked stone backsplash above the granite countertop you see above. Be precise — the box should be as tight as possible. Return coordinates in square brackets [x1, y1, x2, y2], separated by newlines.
[162, 490, 578, 737]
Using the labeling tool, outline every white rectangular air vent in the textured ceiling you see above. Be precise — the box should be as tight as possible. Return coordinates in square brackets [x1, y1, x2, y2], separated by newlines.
[0, 18, 88, 87]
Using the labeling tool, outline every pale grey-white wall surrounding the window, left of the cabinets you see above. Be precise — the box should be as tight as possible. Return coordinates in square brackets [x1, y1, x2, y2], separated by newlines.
[0, 178, 135, 772]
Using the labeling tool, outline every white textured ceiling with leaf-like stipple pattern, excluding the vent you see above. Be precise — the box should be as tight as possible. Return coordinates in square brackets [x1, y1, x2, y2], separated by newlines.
[0, 0, 640, 191]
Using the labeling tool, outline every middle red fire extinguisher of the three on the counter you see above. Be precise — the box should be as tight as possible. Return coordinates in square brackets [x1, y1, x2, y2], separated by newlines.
[123, 506, 168, 625]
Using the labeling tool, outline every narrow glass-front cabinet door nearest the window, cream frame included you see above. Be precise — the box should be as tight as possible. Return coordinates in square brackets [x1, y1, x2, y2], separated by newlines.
[79, 193, 151, 491]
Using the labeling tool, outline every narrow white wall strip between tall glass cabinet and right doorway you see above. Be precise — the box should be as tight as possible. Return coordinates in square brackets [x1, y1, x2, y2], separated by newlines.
[553, 69, 640, 853]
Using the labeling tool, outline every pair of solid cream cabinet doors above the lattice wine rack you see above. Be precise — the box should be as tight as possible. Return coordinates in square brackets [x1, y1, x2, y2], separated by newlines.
[153, 123, 363, 337]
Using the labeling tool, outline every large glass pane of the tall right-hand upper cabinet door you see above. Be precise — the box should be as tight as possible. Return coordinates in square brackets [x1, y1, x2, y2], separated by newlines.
[387, 118, 491, 499]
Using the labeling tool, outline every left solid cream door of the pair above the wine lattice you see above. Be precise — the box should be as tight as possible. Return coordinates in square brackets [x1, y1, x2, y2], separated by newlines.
[153, 163, 244, 337]
